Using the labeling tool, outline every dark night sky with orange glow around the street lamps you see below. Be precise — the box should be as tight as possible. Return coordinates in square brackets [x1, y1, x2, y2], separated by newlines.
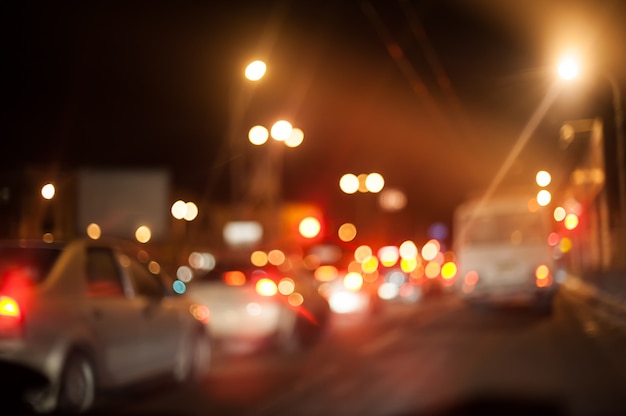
[1, 0, 626, 242]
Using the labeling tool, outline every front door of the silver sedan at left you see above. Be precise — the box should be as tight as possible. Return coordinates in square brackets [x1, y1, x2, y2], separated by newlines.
[126, 256, 184, 373]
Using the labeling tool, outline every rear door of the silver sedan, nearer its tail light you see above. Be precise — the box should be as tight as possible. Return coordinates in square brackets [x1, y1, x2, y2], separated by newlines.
[86, 246, 148, 383]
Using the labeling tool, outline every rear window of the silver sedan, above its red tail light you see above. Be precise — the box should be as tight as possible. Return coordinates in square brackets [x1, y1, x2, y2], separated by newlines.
[0, 247, 61, 288]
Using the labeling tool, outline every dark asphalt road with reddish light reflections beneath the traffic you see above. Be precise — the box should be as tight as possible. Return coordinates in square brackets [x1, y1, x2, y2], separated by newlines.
[83, 290, 626, 416]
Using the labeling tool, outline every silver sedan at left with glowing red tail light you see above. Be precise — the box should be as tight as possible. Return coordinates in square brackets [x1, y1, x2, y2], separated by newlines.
[0, 239, 210, 414]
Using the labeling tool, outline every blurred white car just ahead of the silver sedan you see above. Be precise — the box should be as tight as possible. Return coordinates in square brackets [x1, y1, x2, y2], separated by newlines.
[187, 261, 330, 350]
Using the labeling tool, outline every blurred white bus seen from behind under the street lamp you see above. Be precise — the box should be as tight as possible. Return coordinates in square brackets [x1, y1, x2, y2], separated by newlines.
[454, 195, 558, 310]
